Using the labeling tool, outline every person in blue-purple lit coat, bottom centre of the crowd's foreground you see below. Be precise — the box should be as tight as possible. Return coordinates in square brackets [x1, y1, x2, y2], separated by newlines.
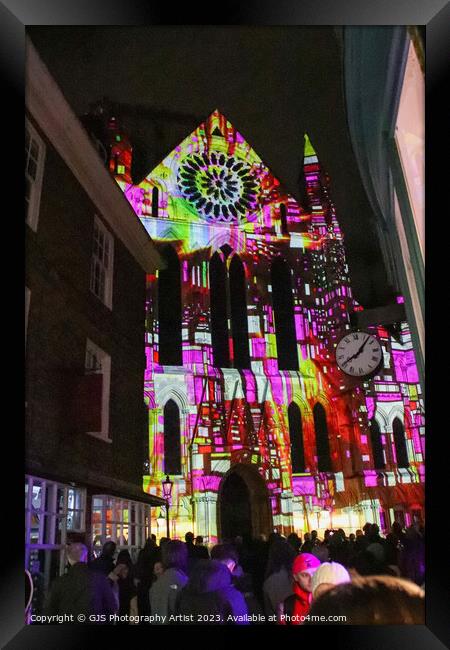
[176, 560, 249, 625]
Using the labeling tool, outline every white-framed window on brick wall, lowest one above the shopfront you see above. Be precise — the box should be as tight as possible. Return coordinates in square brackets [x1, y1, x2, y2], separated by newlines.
[85, 340, 111, 442]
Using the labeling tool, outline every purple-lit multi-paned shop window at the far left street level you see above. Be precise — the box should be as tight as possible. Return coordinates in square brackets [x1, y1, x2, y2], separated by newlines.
[25, 476, 86, 614]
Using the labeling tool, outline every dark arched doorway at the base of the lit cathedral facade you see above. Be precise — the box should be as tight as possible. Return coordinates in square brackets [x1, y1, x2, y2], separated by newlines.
[217, 464, 273, 540]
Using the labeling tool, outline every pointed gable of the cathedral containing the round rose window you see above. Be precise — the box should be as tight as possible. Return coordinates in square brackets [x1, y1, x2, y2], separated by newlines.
[128, 110, 294, 229]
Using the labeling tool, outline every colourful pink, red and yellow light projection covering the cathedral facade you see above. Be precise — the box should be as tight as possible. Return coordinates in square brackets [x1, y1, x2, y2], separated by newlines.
[110, 110, 424, 543]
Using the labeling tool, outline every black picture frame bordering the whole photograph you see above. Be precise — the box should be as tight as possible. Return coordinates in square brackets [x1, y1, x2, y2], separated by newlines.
[5, 0, 444, 650]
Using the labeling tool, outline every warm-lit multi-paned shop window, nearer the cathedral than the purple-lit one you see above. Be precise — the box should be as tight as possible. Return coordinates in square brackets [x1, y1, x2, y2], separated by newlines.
[92, 494, 150, 562]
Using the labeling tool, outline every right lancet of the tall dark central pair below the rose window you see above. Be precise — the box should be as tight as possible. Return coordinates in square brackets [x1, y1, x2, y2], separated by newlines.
[229, 255, 250, 368]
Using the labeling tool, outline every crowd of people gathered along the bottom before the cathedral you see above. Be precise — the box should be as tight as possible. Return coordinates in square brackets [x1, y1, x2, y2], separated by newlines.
[40, 523, 425, 625]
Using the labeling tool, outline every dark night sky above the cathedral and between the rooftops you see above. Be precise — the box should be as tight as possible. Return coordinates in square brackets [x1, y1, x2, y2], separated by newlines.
[27, 26, 387, 307]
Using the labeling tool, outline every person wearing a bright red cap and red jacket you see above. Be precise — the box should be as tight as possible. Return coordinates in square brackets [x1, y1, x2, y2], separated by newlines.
[278, 553, 320, 625]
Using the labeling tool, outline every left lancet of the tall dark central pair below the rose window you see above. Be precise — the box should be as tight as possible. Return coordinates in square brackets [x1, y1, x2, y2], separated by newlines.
[209, 253, 230, 368]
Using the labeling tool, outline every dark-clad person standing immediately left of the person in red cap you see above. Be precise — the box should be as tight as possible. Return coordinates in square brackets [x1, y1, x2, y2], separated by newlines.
[263, 539, 300, 617]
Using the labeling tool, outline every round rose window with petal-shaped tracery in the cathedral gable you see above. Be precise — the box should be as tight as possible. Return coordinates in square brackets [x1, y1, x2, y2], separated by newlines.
[178, 151, 257, 223]
